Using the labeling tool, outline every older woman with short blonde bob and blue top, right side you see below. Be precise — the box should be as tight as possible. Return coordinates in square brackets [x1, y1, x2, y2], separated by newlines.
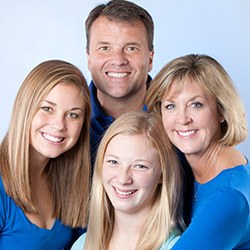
[146, 54, 250, 249]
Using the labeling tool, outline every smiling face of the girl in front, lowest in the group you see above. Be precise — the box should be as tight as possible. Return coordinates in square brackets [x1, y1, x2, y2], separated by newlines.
[102, 134, 161, 213]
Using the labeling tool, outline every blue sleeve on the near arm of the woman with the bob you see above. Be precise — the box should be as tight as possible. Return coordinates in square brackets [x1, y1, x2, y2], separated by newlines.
[173, 188, 249, 250]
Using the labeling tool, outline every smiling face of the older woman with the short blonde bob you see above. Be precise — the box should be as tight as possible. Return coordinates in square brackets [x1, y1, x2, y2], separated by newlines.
[161, 79, 220, 155]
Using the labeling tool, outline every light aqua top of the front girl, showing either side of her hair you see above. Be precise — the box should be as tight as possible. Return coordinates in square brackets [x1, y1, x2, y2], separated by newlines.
[71, 230, 180, 250]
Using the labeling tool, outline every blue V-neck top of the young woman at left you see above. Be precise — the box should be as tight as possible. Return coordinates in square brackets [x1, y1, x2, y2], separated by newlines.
[0, 177, 77, 250]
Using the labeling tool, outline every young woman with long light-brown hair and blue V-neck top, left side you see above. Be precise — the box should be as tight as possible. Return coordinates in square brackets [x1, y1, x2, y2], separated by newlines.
[0, 60, 90, 249]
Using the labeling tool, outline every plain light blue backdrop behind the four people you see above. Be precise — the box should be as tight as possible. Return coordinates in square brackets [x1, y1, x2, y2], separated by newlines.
[0, 0, 250, 157]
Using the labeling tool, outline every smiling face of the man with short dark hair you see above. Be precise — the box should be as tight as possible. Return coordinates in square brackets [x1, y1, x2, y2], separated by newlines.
[87, 16, 154, 98]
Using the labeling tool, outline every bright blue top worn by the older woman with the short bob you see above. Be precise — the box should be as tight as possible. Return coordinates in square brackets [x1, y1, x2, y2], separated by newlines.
[173, 163, 250, 250]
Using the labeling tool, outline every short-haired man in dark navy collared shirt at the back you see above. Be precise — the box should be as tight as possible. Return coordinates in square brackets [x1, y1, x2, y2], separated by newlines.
[85, 0, 154, 165]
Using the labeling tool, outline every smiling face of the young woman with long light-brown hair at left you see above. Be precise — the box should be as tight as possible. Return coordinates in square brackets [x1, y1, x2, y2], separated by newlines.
[30, 83, 84, 162]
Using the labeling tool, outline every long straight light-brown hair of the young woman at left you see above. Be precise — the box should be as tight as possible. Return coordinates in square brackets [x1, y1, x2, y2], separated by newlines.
[0, 60, 90, 227]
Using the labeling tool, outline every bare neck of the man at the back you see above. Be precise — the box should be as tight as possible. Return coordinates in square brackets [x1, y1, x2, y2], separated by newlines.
[97, 89, 146, 119]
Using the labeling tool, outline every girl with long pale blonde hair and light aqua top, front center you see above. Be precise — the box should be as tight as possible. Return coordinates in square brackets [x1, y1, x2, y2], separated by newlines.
[72, 111, 183, 250]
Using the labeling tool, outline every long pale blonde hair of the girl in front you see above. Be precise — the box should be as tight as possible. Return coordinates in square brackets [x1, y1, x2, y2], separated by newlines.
[84, 111, 183, 250]
